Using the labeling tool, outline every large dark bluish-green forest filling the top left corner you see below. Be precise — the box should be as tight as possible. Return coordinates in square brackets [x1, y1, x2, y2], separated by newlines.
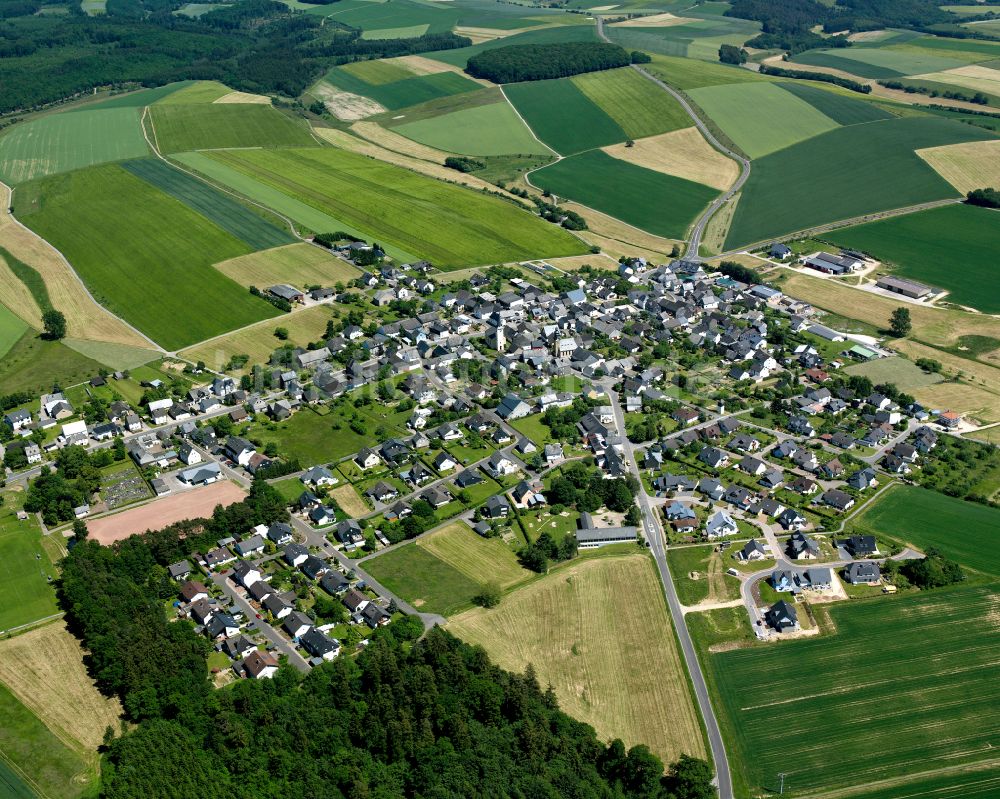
[0, 0, 471, 114]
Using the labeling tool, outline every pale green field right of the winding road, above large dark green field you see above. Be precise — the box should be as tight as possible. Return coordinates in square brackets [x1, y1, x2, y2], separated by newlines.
[689, 83, 837, 158]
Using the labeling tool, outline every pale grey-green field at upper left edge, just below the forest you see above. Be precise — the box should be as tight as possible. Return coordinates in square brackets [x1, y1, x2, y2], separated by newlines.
[0, 108, 149, 185]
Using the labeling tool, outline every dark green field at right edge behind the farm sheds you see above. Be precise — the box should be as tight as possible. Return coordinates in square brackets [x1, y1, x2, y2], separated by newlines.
[826, 204, 1000, 314]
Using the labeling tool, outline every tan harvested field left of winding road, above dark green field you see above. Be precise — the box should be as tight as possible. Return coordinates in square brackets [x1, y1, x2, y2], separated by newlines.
[601, 127, 740, 190]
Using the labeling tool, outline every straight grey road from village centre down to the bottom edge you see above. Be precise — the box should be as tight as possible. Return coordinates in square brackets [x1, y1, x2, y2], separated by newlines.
[607, 386, 733, 799]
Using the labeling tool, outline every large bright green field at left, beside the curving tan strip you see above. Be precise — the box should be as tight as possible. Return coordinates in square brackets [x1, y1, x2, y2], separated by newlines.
[15, 165, 278, 349]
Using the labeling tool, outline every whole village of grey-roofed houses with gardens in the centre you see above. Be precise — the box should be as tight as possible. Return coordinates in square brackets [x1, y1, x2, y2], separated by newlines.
[3, 244, 972, 680]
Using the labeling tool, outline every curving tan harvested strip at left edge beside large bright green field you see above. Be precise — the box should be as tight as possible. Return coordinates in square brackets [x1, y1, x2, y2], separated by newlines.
[0, 183, 152, 348]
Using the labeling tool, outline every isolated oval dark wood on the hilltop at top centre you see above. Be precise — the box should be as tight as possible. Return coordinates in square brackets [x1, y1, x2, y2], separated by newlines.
[465, 42, 631, 83]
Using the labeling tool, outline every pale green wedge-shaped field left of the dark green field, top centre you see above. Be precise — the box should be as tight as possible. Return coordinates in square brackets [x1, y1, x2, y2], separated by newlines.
[393, 100, 549, 155]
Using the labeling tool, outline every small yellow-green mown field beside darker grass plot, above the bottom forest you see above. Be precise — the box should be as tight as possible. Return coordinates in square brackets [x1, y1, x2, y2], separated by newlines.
[417, 521, 531, 589]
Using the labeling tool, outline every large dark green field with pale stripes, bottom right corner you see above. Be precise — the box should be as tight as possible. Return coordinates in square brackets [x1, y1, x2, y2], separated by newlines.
[702, 587, 1000, 796]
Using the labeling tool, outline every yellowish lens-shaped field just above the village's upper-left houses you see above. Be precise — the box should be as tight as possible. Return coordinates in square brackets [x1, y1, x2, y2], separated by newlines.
[215, 247, 360, 294]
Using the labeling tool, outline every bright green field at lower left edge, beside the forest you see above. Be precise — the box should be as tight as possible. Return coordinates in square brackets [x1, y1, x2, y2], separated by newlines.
[0, 491, 58, 630]
